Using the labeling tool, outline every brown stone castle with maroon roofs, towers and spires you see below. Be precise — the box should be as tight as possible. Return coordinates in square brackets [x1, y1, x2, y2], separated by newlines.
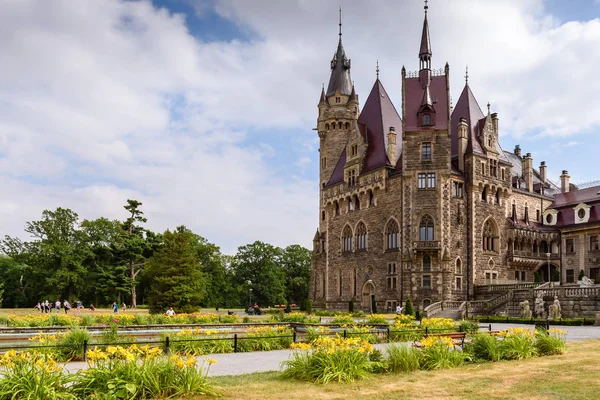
[309, 6, 600, 311]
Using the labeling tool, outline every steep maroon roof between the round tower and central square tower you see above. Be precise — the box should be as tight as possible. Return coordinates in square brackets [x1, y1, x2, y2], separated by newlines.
[358, 79, 402, 173]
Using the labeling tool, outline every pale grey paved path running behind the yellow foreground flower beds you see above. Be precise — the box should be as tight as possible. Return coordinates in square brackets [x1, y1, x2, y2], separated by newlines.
[66, 323, 600, 376]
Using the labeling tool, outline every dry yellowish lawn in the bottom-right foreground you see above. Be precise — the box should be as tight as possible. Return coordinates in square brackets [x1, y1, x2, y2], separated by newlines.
[197, 340, 600, 400]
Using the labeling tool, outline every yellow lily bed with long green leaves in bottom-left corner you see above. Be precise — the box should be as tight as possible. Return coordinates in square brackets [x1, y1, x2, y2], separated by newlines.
[0, 345, 218, 400]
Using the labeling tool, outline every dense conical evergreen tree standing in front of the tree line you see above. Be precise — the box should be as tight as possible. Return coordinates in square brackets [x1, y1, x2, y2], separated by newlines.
[146, 226, 207, 313]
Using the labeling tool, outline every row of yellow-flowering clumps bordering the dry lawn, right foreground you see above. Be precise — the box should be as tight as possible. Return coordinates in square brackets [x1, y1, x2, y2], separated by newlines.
[283, 328, 566, 383]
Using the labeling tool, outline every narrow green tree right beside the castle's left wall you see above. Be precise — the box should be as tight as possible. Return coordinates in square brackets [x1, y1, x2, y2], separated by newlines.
[280, 244, 311, 305]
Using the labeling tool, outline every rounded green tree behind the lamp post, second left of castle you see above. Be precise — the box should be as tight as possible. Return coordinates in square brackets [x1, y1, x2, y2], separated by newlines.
[231, 241, 285, 307]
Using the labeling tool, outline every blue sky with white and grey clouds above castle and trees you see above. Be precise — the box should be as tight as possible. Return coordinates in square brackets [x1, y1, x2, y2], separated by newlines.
[0, 0, 600, 253]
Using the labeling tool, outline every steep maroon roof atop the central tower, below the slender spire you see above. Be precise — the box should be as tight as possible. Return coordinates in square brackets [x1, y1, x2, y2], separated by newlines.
[404, 75, 448, 131]
